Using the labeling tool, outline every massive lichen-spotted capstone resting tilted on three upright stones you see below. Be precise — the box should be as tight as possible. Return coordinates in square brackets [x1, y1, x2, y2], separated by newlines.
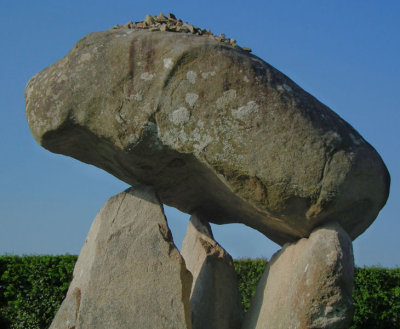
[26, 28, 390, 245]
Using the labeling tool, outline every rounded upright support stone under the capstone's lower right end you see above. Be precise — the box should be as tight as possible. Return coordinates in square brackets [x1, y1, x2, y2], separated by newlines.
[242, 224, 354, 329]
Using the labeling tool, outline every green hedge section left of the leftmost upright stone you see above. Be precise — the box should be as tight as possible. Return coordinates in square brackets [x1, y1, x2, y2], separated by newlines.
[0, 255, 77, 329]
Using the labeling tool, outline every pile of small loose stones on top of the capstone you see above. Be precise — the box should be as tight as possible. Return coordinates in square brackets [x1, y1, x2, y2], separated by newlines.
[112, 13, 251, 52]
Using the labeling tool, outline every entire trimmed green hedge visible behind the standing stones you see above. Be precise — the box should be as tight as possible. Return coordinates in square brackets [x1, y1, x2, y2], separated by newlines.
[0, 255, 400, 329]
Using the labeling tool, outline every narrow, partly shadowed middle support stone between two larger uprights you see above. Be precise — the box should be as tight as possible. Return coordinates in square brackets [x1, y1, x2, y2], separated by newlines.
[181, 215, 242, 329]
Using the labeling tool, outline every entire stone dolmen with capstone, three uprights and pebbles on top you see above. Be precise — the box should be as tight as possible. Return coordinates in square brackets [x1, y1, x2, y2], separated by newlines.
[25, 14, 390, 329]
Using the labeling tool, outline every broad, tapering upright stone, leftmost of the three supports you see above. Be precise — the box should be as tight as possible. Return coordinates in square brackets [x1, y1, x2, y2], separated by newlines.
[50, 187, 192, 329]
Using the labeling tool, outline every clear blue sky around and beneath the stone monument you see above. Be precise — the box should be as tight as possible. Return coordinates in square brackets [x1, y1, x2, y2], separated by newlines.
[0, 0, 400, 267]
